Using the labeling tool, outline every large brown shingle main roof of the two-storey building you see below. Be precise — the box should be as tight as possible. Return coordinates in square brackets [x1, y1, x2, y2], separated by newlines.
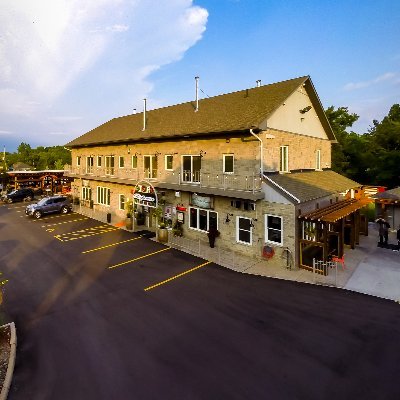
[67, 77, 335, 147]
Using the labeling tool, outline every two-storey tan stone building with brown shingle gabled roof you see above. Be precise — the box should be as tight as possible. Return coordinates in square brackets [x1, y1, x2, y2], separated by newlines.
[67, 76, 363, 268]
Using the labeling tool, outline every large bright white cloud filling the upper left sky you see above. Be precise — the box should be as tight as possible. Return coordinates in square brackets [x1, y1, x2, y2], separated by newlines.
[0, 0, 208, 147]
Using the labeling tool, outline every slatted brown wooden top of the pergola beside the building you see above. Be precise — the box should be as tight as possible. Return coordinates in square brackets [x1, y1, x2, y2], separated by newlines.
[299, 198, 373, 223]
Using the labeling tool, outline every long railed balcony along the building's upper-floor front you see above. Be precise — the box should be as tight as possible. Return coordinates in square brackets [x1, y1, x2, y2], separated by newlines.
[65, 166, 261, 193]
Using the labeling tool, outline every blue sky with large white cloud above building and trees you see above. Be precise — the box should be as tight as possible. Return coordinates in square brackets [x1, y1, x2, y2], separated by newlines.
[0, 0, 400, 151]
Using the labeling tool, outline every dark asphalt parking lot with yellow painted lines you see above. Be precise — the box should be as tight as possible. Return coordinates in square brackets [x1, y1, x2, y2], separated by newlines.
[0, 203, 400, 400]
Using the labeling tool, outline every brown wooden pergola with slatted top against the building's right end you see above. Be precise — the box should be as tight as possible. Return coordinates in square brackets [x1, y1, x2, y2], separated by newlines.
[298, 197, 373, 269]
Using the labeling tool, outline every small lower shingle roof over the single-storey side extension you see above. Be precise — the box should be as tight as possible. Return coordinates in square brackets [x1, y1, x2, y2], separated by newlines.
[265, 170, 361, 203]
